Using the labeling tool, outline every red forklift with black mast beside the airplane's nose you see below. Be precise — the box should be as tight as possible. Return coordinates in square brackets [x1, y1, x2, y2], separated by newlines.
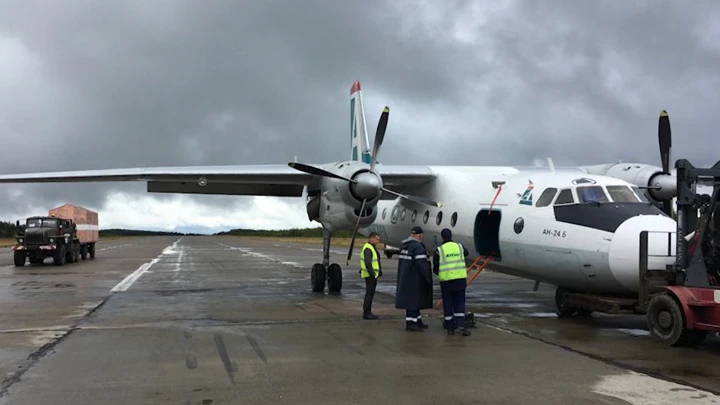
[636, 159, 720, 347]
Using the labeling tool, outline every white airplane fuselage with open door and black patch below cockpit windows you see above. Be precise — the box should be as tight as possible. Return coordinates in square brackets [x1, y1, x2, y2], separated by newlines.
[360, 166, 676, 294]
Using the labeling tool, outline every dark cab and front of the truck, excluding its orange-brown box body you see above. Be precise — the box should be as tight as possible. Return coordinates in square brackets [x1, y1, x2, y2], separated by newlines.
[13, 216, 80, 267]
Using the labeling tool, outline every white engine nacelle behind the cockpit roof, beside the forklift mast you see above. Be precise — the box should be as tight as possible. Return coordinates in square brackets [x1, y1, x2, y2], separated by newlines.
[583, 163, 677, 201]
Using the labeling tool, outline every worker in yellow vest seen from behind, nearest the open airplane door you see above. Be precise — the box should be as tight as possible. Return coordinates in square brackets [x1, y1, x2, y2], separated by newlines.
[433, 228, 470, 336]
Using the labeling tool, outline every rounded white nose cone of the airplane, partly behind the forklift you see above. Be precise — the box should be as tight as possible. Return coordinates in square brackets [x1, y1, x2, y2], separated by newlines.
[608, 215, 677, 292]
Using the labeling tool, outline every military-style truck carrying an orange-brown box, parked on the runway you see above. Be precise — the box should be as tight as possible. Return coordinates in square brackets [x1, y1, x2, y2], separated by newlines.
[13, 204, 100, 267]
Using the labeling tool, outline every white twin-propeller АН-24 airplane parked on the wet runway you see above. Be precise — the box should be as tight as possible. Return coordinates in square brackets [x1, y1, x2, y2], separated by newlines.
[0, 81, 688, 316]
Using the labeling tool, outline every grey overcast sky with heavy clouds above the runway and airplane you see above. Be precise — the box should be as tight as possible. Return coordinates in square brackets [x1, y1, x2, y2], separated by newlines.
[0, 0, 720, 231]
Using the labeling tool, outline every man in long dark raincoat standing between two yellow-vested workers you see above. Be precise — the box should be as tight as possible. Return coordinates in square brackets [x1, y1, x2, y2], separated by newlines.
[395, 226, 433, 332]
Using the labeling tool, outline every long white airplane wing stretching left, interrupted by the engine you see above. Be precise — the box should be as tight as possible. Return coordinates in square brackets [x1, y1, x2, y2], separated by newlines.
[0, 164, 434, 197]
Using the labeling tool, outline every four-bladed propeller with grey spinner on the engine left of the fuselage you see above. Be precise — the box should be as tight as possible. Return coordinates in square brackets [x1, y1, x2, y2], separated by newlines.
[288, 106, 442, 264]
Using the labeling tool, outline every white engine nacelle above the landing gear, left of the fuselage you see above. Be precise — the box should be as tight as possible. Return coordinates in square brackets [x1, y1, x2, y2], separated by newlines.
[307, 162, 382, 231]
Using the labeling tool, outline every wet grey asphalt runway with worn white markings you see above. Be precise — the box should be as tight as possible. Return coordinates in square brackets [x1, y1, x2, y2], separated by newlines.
[0, 237, 720, 405]
